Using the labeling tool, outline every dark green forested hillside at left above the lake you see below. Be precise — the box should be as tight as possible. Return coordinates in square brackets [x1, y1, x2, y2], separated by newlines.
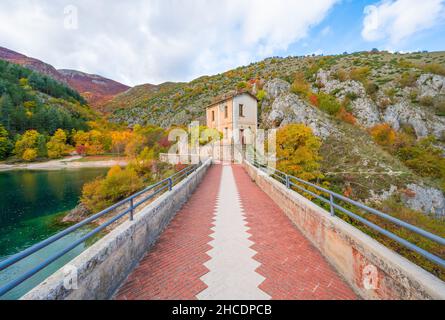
[0, 61, 96, 158]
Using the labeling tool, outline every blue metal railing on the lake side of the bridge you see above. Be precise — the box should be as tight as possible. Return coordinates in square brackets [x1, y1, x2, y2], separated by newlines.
[0, 162, 202, 297]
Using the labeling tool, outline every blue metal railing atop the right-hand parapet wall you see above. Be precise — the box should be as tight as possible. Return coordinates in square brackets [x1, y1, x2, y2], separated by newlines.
[249, 160, 445, 268]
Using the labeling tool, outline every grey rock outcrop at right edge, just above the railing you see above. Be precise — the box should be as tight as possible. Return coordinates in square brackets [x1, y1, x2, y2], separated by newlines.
[403, 184, 445, 216]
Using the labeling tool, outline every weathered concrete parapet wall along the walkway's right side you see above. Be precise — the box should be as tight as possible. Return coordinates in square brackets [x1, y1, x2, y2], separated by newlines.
[244, 163, 445, 300]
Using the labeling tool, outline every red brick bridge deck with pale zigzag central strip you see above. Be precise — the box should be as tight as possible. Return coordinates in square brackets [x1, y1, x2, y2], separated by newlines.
[116, 165, 356, 300]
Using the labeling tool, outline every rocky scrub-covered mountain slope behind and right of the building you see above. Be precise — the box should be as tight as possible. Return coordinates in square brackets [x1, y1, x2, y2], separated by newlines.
[106, 52, 445, 215]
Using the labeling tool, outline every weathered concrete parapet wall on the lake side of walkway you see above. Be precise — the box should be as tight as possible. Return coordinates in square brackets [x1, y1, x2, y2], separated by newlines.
[22, 160, 211, 300]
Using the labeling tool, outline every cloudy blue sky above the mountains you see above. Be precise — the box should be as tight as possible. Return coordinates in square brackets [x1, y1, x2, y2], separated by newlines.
[0, 0, 445, 86]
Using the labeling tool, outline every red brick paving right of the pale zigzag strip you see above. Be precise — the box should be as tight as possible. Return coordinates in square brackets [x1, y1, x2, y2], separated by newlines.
[233, 166, 356, 300]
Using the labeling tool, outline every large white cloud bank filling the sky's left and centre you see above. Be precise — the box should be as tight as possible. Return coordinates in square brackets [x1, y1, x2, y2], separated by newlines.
[0, 0, 340, 84]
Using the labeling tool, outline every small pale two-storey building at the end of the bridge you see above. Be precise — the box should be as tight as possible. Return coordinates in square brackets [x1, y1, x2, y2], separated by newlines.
[206, 92, 258, 145]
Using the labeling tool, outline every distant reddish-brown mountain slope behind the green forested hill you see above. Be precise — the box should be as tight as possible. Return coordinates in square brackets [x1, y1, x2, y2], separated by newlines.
[0, 47, 130, 110]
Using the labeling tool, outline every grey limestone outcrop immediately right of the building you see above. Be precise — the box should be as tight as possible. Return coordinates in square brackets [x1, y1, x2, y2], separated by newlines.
[267, 94, 337, 138]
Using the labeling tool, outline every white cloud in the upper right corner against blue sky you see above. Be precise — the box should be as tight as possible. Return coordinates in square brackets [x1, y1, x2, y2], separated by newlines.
[362, 0, 445, 45]
